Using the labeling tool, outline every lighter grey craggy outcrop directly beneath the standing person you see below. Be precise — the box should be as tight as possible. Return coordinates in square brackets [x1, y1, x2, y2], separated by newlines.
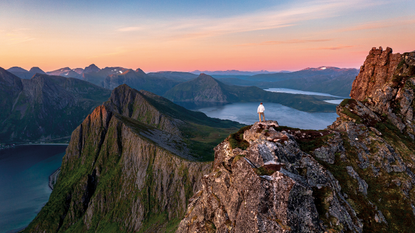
[177, 121, 362, 232]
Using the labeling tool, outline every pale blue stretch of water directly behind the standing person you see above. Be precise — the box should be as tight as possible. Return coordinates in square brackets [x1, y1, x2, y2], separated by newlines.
[197, 103, 338, 130]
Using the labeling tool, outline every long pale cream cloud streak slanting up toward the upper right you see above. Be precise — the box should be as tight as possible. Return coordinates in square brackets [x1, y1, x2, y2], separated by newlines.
[118, 0, 382, 40]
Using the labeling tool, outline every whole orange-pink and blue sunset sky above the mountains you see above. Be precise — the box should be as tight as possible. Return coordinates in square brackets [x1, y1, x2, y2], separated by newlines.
[0, 0, 415, 72]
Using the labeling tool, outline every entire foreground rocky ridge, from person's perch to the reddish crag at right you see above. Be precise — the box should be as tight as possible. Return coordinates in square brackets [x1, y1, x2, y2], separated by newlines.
[177, 48, 415, 232]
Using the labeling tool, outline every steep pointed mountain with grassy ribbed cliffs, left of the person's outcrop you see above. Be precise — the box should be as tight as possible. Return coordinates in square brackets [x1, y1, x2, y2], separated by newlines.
[25, 85, 240, 232]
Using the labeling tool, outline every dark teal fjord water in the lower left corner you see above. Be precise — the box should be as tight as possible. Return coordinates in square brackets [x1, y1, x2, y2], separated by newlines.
[0, 145, 67, 233]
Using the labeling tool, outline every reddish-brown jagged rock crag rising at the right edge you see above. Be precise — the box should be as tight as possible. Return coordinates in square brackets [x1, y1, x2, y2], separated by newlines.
[346, 47, 415, 138]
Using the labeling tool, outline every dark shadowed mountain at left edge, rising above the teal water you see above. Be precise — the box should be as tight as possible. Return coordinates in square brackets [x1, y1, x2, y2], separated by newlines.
[0, 69, 110, 142]
